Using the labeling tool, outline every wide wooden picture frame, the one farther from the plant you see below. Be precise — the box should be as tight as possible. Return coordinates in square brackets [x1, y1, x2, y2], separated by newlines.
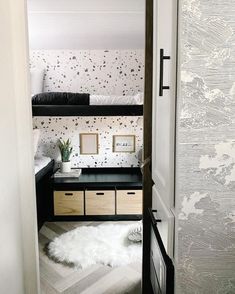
[113, 135, 136, 153]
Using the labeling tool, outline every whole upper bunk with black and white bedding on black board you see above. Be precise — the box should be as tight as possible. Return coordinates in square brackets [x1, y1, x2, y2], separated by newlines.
[32, 92, 143, 116]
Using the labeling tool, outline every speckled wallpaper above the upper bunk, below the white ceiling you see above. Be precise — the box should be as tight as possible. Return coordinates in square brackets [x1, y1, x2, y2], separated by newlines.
[30, 50, 144, 95]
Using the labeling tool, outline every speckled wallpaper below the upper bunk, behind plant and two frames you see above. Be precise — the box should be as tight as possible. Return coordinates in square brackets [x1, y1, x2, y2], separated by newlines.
[33, 116, 143, 168]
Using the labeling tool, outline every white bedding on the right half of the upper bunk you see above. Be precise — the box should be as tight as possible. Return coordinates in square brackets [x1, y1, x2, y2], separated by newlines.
[90, 93, 144, 105]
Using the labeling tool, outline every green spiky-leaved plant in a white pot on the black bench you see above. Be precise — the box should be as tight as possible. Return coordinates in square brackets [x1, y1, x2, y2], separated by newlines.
[58, 139, 73, 173]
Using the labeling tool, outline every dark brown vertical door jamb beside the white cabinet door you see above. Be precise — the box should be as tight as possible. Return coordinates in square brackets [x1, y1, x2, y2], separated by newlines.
[142, 0, 153, 294]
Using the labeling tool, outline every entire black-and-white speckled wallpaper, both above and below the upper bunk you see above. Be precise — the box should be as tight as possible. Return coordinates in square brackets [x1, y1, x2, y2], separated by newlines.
[30, 50, 144, 167]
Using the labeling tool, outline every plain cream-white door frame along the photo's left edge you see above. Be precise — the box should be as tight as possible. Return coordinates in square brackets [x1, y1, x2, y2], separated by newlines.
[0, 0, 40, 294]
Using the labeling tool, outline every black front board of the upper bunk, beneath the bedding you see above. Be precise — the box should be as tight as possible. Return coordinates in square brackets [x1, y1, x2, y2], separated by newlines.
[32, 105, 143, 116]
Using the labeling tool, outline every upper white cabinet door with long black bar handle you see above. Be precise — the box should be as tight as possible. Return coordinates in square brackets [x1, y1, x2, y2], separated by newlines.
[152, 0, 177, 209]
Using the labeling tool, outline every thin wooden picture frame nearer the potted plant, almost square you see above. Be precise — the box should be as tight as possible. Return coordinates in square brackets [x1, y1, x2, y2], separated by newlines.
[79, 133, 99, 155]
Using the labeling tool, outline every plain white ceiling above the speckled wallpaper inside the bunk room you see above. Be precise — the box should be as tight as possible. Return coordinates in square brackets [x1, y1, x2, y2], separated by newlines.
[28, 0, 145, 50]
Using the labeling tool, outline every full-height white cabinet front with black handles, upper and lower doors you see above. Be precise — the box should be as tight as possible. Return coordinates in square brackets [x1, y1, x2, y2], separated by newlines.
[150, 0, 177, 294]
